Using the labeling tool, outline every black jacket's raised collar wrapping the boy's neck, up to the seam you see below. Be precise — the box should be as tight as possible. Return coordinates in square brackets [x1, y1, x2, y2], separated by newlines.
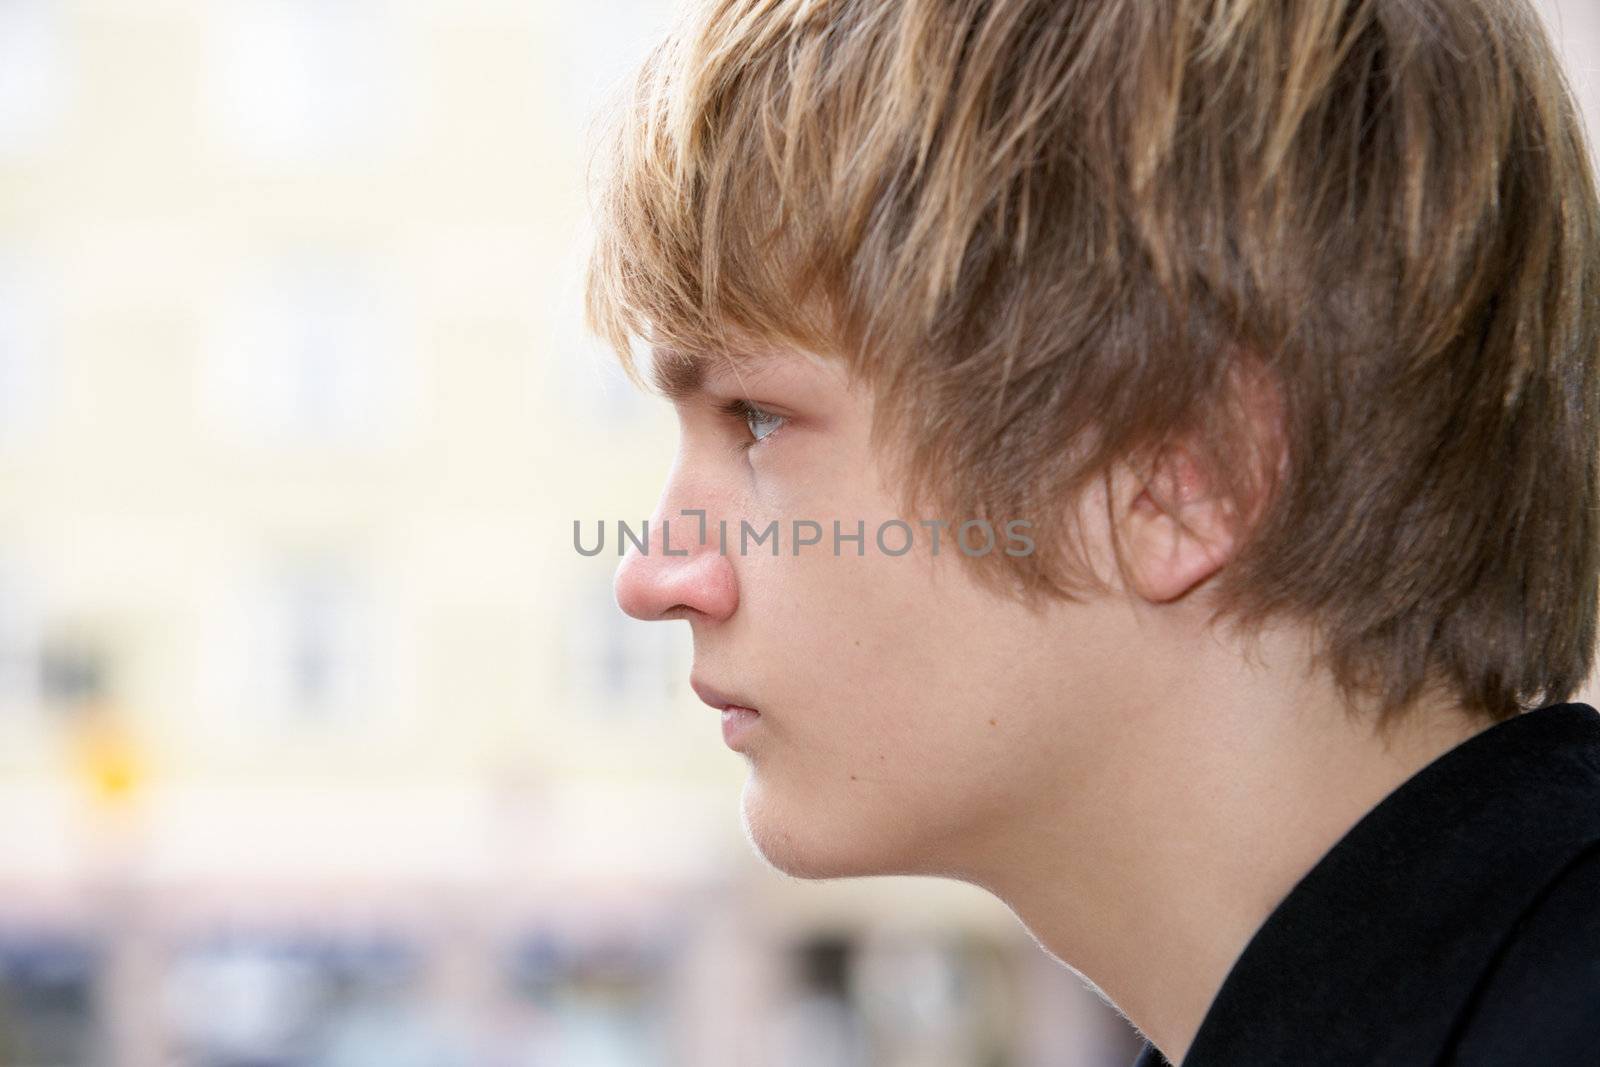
[1134, 702, 1600, 1067]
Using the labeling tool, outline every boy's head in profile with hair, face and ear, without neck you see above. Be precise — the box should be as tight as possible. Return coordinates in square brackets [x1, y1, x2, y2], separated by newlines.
[589, 0, 1600, 872]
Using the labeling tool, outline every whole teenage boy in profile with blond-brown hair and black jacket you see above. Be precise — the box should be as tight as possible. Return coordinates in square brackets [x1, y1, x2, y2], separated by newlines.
[587, 0, 1600, 1067]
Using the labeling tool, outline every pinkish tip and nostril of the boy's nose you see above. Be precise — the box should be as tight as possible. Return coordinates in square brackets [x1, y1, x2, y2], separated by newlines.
[613, 515, 739, 622]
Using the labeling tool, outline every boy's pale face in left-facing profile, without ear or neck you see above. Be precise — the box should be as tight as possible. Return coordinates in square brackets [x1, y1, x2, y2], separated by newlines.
[616, 354, 1209, 881]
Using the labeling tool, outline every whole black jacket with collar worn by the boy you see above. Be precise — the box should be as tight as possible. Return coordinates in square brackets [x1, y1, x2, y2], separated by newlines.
[1134, 704, 1600, 1067]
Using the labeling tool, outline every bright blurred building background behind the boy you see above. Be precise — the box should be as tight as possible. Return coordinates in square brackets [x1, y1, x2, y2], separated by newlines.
[0, 0, 1600, 1067]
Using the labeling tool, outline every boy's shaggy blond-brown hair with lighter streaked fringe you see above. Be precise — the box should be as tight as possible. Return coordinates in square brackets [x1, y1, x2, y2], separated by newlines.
[587, 0, 1600, 720]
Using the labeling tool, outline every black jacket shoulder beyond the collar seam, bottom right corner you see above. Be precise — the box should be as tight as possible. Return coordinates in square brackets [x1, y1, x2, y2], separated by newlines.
[1450, 841, 1600, 1067]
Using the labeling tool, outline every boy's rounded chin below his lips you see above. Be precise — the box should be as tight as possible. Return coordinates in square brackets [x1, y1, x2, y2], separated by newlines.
[739, 776, 930, 880]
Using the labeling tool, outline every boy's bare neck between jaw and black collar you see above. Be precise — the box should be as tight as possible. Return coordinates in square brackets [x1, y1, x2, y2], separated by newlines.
[973, 652, 1486, 1064]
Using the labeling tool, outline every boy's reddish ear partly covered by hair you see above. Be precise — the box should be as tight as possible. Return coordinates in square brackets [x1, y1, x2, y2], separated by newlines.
[1112, 445, 1237, 603]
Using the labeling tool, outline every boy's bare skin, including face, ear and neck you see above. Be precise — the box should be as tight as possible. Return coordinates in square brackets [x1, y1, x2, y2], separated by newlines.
[616, 348, 1485, 1062]
